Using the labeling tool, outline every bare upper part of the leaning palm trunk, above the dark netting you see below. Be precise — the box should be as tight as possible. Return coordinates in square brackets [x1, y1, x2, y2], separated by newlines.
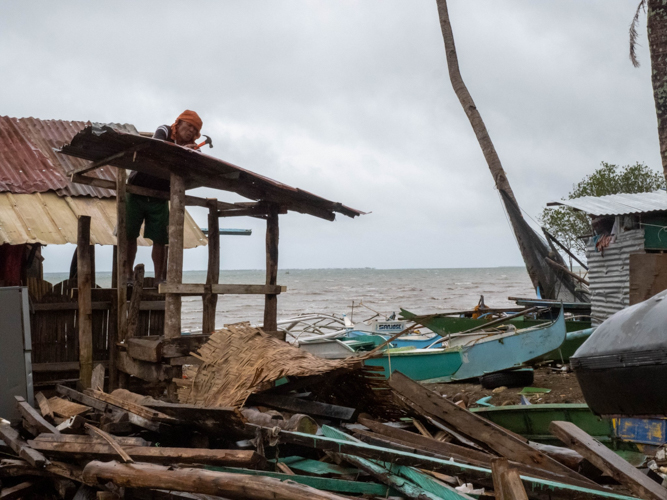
[437, 0, 516, 203]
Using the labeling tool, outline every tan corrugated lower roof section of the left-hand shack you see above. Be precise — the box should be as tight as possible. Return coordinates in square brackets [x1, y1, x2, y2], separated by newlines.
[0, 191, 208, 248]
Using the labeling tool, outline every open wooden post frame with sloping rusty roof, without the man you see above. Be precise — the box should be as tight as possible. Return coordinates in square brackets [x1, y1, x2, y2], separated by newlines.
[60, 126, 363, 389]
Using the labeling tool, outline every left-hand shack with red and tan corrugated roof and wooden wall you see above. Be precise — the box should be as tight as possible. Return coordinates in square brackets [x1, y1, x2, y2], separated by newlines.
[0, 116, 207, 388]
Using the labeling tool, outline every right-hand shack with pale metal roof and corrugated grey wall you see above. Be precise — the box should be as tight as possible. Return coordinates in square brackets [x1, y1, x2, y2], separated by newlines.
[549, 191, 667, 324]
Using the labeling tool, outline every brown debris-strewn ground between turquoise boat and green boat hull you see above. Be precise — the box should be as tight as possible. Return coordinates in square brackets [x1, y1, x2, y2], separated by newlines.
[427, 367, 585, 408]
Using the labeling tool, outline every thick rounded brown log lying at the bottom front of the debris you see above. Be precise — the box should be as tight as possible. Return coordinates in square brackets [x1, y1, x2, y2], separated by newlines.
[83, 460, 343, 500]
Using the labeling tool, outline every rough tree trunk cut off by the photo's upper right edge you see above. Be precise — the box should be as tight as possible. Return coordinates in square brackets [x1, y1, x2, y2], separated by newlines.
[647, 0, 667, 179]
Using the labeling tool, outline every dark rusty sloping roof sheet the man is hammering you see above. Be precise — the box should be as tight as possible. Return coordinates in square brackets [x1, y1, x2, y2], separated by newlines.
[61, 125, 363, 220]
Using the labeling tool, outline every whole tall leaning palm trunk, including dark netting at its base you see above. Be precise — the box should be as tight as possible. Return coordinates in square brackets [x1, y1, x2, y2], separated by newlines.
[437, 0, 588, 302]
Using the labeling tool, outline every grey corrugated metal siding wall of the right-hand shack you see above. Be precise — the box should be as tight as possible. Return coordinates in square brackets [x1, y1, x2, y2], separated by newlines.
[586, 229, 646, 325]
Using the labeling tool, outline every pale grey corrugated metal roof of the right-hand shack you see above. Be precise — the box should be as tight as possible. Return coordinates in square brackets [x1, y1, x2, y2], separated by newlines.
[549, 190, 667, 215]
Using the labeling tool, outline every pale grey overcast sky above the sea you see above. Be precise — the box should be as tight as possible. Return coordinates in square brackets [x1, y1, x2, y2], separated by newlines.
[0, 0, 660, 272]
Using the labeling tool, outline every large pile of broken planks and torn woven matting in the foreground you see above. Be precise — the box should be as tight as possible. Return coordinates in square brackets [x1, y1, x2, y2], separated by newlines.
[0, 328, 667, 500]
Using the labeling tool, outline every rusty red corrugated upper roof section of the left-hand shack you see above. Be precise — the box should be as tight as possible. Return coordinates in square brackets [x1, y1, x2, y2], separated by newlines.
[0, 116, 137, 198]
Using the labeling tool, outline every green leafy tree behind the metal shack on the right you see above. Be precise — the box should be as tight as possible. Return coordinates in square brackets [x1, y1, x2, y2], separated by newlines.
[540, 162, 665, 256]
